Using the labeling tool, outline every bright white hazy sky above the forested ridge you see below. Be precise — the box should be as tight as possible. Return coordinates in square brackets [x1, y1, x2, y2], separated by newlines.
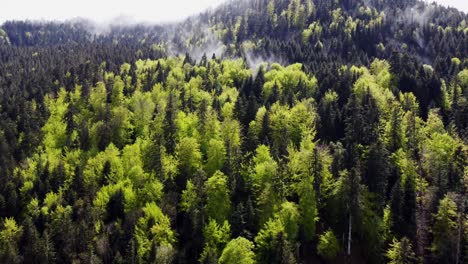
[0, 0, 468, 23]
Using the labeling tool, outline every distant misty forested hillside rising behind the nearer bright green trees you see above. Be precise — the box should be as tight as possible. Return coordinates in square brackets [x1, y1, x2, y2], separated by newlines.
[0, 0, 468, 115]
